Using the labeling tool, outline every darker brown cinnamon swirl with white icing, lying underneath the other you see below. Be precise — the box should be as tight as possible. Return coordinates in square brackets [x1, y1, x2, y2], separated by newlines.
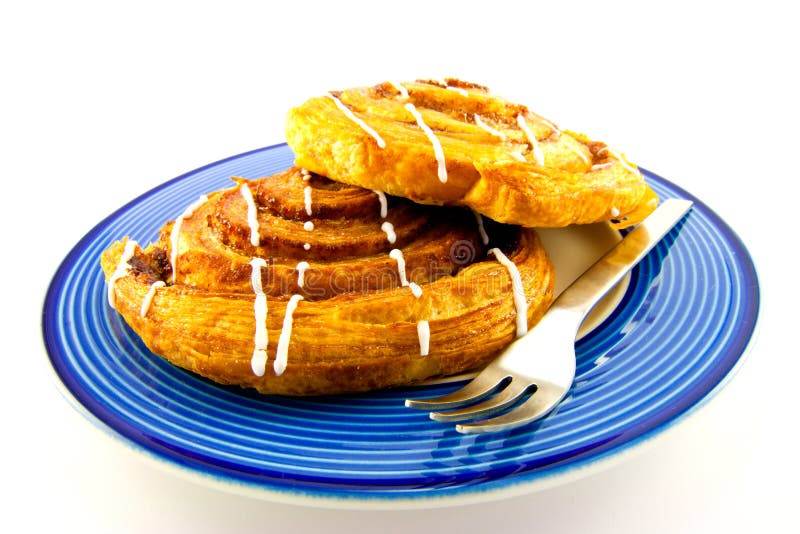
[102, 168, 553, 395]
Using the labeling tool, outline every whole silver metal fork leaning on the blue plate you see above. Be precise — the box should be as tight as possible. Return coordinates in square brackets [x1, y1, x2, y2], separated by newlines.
[405, 199, 692, 434]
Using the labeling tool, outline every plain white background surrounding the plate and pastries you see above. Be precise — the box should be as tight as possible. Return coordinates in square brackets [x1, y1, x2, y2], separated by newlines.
[0, 0, 800, 533]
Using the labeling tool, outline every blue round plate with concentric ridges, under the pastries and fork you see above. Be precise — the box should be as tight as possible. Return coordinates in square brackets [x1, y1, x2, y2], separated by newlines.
[43, 145, 759, 507]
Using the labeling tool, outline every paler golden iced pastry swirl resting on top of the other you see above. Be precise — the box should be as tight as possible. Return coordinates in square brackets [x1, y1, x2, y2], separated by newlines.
[286, 78, 658, 227]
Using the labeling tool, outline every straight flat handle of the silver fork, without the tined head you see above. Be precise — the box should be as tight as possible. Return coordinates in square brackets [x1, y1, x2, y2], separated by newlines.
[551, 198, 692, 318]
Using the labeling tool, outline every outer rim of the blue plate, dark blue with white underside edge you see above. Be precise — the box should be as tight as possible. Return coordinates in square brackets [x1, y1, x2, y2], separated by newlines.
[41, 143, 762, 509]
